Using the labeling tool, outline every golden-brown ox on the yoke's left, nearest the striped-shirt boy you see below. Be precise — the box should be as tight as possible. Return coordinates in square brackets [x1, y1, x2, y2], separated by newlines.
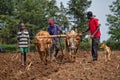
[34, 31, 52, 64]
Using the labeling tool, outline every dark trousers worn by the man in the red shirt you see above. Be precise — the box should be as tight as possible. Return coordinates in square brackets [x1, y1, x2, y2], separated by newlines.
[92, 37, 100, 60]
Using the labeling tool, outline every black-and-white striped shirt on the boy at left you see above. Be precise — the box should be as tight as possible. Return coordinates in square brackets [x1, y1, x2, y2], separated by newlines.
[17, 30, 29, 47]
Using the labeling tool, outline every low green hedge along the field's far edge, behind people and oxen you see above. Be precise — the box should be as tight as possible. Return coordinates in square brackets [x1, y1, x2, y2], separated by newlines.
[1, 41, 120, 53]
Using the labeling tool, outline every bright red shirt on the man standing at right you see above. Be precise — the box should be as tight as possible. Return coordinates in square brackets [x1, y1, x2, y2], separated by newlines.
[88, 18, 101, 38]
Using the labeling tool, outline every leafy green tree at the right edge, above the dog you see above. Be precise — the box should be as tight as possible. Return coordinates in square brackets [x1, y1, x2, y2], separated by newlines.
[107, 0, 120, 42]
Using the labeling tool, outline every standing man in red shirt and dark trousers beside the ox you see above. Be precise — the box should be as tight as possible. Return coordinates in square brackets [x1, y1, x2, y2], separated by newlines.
[85, 11, 101, 61]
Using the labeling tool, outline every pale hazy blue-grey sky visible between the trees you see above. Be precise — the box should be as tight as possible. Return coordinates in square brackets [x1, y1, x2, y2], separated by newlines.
[57, 0, 115, 41]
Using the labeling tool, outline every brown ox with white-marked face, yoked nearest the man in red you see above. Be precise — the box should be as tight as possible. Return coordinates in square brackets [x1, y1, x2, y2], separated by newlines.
[65, 30, 81, 61]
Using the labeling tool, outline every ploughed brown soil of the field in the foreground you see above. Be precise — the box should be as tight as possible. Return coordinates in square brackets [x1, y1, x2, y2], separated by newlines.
[0, 51, 120, 80]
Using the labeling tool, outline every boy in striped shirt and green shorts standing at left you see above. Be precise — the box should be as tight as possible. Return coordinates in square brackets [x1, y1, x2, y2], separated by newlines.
[17, 23, 30, 65]
